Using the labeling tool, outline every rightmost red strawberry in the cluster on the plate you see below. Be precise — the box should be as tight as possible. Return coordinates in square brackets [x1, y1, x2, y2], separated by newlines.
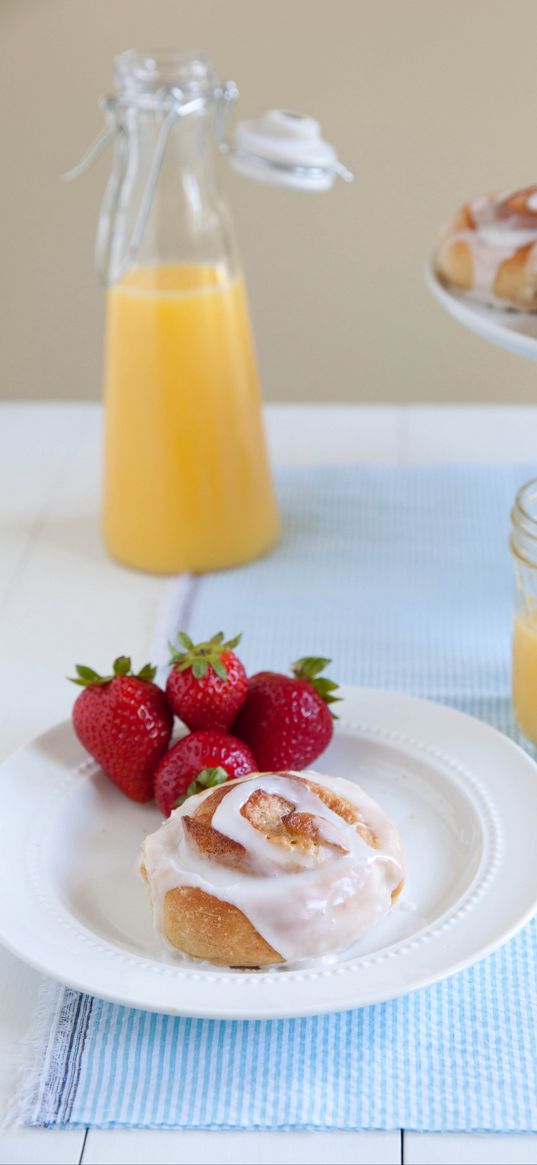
[233, 657, 338, 772]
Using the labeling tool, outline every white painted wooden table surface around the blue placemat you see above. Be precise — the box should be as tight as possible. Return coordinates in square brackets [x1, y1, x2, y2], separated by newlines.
[0, 403, 537, 1165]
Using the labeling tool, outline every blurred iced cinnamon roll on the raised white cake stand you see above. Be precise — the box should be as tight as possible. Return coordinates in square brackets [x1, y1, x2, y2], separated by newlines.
[436, 186, 537, 311]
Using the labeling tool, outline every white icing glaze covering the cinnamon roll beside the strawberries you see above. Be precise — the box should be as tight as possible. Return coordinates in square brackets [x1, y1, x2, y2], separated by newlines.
[141, 772, 404, 962]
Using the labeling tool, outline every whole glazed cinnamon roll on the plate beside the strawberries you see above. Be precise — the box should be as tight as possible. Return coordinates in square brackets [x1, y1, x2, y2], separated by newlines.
[140, 772, 404, 967]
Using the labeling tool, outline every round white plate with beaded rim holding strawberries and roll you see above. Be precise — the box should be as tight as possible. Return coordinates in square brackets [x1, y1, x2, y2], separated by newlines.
[0, 687, 537, 1018]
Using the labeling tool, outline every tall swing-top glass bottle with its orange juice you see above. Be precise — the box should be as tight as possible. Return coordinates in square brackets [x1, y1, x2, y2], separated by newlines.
[98, 51, 278, 572]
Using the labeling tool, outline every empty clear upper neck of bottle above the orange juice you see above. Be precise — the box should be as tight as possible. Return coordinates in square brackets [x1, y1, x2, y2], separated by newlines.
[97, 52, 235, 283]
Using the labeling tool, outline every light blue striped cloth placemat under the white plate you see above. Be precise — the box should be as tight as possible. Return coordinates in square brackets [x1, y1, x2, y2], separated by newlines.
[14, 466, 537, 1131]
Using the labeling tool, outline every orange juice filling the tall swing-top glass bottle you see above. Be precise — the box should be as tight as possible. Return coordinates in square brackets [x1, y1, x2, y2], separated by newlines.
[104, 263, 277, 571]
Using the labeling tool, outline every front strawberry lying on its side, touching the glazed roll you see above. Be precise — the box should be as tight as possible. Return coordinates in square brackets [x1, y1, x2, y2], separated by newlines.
[155, 732, 257, 817]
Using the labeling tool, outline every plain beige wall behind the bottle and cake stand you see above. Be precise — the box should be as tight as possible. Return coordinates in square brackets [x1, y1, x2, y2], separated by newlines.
[0, 0, 537, 402]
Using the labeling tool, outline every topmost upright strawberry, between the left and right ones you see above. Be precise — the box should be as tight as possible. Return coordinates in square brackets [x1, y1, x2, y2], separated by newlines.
[165, 631, 248, 732]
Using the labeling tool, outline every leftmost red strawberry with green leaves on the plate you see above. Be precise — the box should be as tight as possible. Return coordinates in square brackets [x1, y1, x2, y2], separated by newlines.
[72, 656, 174, 802]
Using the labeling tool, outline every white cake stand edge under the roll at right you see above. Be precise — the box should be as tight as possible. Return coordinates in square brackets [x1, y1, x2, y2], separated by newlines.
[425, 267, 537, 360]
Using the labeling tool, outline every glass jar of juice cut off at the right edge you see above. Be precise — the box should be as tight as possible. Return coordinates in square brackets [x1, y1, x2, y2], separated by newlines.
[510, 479, 537, 744]
